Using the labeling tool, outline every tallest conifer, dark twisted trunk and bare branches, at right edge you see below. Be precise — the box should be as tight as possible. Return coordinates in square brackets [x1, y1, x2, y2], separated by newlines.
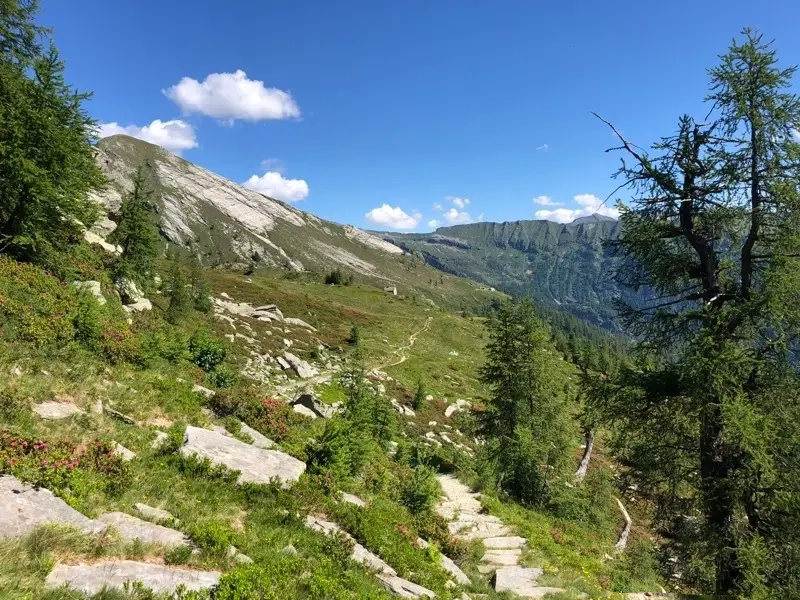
[589, 30, 800, 598]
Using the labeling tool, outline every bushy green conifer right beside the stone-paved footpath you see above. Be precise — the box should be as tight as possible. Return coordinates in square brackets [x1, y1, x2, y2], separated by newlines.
[479, 299, 570, 504]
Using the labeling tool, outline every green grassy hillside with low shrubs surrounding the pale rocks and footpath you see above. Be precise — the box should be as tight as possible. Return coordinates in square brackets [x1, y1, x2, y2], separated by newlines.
[0, 245, 657, 600]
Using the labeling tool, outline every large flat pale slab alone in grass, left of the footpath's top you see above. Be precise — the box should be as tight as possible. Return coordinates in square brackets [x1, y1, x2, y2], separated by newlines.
[180, 425, 306, 487]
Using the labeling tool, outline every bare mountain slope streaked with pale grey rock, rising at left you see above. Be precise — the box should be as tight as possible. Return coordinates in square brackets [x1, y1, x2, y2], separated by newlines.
[90, 135, 490, 308]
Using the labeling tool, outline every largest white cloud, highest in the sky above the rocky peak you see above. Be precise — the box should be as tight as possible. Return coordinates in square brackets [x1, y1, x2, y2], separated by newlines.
[163, 69, 300, 121]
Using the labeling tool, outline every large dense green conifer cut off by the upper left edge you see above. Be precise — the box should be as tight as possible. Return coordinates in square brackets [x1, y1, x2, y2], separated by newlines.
[0, 0, 104, 263]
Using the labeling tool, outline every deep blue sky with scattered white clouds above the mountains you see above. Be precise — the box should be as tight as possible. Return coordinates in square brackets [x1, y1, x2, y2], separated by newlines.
[40, 0, 800, 231]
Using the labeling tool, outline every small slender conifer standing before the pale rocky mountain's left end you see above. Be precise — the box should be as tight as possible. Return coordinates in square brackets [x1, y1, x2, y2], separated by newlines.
[111, 164, 160, 288]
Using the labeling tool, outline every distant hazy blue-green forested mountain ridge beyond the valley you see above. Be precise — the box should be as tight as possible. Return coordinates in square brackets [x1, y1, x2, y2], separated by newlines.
[380, 215, 635, 329]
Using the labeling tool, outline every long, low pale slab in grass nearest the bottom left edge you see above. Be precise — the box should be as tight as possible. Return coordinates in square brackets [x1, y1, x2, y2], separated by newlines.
[45, 560, 220, 594]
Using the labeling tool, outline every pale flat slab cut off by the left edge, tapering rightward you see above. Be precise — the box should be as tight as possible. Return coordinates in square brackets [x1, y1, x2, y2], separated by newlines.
[0, 475, 106, 538]
